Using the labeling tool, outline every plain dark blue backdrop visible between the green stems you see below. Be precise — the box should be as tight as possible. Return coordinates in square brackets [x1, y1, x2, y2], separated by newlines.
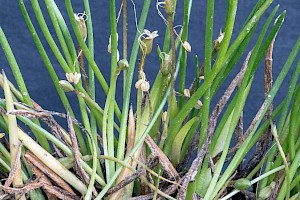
[0, 0, 300, 125]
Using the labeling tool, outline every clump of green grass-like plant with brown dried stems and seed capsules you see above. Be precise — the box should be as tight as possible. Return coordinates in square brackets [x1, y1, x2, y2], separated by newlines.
[0, 0, 300, 200]
